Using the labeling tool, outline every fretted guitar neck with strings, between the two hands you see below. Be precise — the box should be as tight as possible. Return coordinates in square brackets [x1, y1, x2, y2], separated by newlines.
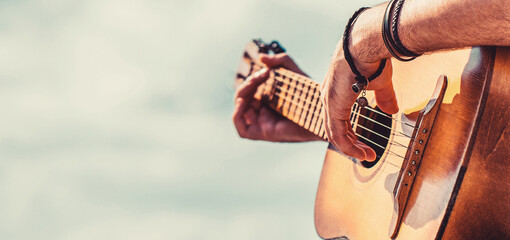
[256, 68, 327, 140]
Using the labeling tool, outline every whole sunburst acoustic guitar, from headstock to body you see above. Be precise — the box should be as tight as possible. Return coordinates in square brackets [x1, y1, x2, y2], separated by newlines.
[236, 40, 510, 240]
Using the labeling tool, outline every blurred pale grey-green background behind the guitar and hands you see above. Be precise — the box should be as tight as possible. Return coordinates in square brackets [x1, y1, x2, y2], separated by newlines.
[0, 0, 381, 240]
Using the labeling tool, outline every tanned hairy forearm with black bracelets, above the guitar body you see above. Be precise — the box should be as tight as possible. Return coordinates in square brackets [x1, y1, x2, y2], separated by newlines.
[350, 0, 510, 62]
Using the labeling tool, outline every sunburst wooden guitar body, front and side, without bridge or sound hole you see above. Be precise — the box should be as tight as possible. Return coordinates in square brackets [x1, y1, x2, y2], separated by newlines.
[315, 47, 510, 240]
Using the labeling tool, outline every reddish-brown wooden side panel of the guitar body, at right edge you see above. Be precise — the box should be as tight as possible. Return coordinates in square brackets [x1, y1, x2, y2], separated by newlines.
[443, 47, 510, 239]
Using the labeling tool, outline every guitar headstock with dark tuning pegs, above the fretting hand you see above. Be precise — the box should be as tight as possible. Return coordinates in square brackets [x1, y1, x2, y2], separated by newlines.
[234, 39, 285, 88]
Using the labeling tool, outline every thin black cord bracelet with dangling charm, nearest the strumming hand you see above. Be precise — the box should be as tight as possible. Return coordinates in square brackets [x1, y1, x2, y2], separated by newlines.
[342, 7, 386, 93]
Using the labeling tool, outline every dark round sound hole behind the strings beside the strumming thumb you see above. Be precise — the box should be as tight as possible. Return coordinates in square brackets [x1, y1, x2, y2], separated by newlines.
[356, 107, 392, 168]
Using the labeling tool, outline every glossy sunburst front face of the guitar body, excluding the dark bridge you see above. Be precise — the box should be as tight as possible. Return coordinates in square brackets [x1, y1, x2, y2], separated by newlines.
[315, 47, 500, 239]
